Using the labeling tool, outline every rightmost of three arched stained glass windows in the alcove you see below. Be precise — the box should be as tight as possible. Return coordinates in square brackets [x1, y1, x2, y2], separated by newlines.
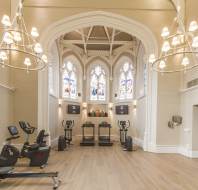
[119, 62, 133, 100]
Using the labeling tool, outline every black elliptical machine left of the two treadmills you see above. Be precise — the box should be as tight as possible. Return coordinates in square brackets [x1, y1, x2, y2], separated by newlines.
[58, 120, 74, 151]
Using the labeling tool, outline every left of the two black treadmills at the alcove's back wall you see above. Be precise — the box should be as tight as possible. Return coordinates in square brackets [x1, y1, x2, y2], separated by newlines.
[80, 122, 95, 146]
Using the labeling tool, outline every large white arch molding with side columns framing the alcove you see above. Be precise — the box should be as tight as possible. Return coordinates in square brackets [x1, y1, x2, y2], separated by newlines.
[38, 11, 158, 151]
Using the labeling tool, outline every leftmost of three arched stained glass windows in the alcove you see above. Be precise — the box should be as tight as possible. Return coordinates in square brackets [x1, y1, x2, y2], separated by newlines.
[63, 61, 77, 99]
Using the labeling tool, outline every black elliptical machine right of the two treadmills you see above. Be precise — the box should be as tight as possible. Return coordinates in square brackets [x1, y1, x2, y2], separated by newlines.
[118, 120, 133, 151]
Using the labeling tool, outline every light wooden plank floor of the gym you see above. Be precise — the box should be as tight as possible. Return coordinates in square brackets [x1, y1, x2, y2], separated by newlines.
[0, 144, 198, 190]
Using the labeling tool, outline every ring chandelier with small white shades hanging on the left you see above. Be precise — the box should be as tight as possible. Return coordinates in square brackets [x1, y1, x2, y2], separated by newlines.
[0, 1, 47, 72]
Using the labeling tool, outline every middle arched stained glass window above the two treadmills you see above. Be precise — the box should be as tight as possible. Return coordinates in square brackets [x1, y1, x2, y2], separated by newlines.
[90, 65, 106, 101]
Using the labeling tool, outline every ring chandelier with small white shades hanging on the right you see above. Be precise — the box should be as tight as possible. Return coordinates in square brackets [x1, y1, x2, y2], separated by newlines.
[149, 7, 198, 73]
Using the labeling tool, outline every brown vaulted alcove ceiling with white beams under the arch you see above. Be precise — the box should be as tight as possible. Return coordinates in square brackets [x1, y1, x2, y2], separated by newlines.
[61, 26, 139, 56]
